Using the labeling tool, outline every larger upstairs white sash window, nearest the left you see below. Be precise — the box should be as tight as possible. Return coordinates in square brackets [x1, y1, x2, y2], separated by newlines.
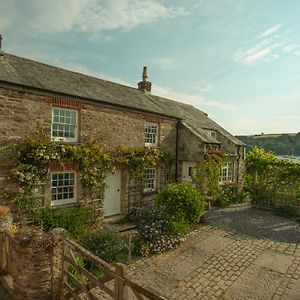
[51, 107, 78, 142]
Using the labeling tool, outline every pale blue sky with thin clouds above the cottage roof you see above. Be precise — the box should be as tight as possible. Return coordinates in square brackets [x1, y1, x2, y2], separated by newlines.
[0, 0, 300, 135]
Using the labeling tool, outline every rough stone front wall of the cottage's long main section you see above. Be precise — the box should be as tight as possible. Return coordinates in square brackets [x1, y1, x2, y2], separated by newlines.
[0, 84, 177, 216]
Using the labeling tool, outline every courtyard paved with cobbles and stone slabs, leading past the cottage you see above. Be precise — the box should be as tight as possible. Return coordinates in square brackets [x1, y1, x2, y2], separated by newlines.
[129, 204, 300, 300]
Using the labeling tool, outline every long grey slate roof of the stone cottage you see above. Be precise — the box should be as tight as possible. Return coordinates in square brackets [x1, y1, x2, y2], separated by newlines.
[0, 51, 244, 145]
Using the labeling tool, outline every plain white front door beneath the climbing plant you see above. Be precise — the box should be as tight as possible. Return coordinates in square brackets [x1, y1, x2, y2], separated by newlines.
[104, 171, 121, 216]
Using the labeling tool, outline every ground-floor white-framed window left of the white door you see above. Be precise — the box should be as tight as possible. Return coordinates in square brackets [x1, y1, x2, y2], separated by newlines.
[51, 172, 76, 206]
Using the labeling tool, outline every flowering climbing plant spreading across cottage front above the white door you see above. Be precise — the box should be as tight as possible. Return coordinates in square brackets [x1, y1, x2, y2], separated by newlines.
[4, 129, 172, 230]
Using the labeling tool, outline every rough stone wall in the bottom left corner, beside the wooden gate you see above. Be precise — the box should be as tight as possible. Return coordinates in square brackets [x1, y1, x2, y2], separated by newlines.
[0, 208, 65, 300]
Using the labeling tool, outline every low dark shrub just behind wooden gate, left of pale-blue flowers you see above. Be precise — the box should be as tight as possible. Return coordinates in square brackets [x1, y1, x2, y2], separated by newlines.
[80, 230, 129, 263]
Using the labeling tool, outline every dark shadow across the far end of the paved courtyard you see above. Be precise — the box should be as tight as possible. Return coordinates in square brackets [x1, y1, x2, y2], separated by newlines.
[205, 203, 300, 243]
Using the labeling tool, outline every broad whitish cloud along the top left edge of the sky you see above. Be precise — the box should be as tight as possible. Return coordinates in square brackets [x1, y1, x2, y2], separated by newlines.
[0, 0, 190, 34]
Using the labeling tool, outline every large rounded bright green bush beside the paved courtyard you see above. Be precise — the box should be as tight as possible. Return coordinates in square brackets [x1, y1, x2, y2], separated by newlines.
[155, 183, 204, 225]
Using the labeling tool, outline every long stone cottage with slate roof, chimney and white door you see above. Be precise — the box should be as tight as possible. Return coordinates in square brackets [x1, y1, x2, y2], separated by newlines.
[0, 38, 245, 216]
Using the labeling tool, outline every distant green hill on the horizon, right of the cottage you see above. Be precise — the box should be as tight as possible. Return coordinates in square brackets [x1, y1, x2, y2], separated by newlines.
[237, 132, 300, 156]
